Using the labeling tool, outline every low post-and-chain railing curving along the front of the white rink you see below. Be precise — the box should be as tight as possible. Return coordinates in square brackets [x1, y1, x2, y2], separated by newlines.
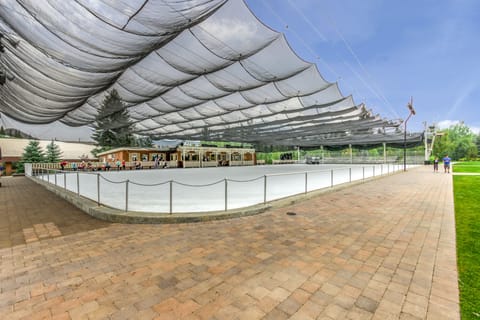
[31, 164, 410, 213]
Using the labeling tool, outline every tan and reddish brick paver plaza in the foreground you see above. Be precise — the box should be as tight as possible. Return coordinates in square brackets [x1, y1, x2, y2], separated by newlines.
[0, 167, 460, 320]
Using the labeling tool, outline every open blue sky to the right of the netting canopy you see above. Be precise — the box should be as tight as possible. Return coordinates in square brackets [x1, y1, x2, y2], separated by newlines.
[246, 0, 480, 132]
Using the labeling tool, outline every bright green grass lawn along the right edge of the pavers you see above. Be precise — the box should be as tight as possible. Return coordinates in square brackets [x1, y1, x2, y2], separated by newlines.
[453, 163, 480, 320]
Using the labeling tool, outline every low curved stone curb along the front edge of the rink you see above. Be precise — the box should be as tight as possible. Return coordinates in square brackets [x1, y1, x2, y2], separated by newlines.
[28, 171, 403, 224]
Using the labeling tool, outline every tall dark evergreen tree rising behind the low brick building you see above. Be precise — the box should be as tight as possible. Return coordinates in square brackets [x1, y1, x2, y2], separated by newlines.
[92, 89, 134, 151]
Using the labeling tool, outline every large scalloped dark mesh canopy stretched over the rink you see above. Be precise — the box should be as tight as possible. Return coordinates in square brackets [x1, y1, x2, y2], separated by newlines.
[0, 0, 418, 146]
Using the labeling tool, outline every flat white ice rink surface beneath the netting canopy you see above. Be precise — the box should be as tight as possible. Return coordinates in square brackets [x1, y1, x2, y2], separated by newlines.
[37, 164, 403, 213]
